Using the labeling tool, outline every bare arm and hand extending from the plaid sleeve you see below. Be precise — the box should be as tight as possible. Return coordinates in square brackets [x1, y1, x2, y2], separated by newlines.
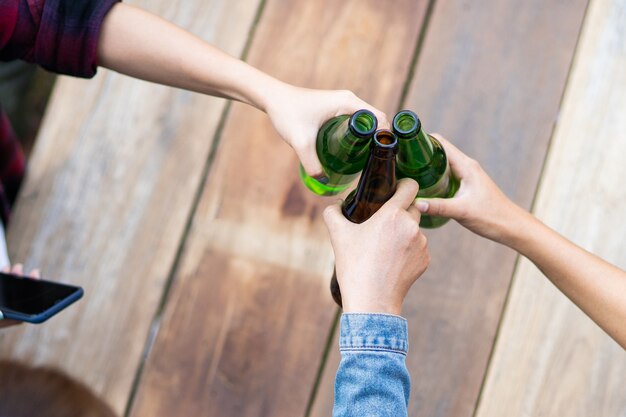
[98, 3, 389, 176]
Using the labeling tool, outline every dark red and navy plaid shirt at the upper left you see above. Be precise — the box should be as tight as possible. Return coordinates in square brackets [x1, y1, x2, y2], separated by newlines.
[0, 0, 118, 224]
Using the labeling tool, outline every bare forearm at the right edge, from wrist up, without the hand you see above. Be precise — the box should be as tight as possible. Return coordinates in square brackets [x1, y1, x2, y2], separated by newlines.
[503, 210, 626, 349]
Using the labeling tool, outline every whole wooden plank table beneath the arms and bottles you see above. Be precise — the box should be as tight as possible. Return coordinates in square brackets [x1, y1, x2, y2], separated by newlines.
[0, 0, 626, 417]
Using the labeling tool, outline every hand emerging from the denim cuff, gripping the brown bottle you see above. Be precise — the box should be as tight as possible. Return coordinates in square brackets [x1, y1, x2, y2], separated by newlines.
[324, 179, 430, 315]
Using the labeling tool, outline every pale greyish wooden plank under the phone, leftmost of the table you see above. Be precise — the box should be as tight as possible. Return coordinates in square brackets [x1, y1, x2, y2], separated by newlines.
[0, 0, 259, 413]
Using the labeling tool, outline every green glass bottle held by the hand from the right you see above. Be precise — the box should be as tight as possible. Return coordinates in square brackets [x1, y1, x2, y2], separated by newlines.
[393, 110, 459, 229]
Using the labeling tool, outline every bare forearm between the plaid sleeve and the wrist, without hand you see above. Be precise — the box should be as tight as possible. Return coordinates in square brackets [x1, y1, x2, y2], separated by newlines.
[98, 4, 285, 111]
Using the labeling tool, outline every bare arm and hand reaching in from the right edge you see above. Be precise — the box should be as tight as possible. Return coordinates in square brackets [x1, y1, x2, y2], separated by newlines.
[417, 137, 626, 349]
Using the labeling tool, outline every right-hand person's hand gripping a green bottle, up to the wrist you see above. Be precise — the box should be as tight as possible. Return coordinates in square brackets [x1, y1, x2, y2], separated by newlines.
[416, 134, 530, 246]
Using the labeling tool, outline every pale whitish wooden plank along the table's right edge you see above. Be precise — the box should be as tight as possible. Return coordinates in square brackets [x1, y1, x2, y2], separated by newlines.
[477, 0, 626, 417]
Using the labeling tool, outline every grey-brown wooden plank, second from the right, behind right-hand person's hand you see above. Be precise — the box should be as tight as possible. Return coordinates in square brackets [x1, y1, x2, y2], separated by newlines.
[312, 0, 586, 417]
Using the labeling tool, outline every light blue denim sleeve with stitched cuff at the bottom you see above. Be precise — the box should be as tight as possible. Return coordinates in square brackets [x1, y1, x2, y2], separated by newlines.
[333, 313, 411, 417]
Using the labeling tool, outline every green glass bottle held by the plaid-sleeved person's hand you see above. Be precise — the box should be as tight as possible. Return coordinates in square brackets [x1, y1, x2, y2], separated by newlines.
[300, 110, 378, 196]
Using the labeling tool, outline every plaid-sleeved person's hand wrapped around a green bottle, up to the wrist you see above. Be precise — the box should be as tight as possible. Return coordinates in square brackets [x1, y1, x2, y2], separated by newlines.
[265, 84, 389, 177]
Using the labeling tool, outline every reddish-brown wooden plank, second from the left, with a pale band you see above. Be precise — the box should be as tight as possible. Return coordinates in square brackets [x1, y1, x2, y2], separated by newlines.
[132, 0, 426, 417]
